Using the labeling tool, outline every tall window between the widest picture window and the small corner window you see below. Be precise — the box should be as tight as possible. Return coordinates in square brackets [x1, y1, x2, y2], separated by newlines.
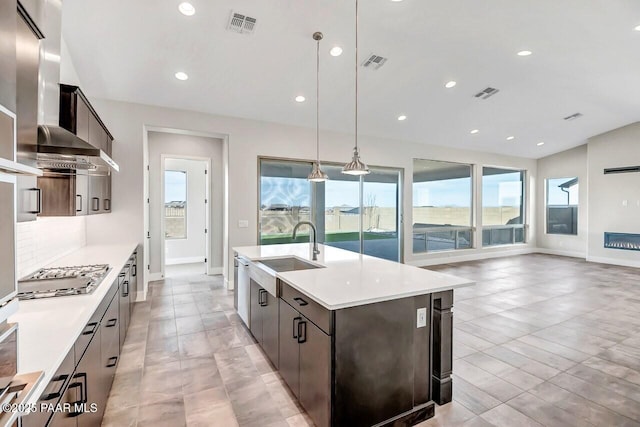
[482, 167, 525, 246]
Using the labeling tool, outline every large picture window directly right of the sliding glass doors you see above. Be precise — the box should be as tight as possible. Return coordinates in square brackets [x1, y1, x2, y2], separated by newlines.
[413, 159, 473, 253]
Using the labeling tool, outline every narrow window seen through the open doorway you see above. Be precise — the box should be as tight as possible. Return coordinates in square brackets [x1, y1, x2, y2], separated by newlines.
[164, 170, 187, 239]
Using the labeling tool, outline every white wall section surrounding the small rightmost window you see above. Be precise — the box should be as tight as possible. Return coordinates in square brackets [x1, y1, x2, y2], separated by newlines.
[536, 144, 589, 258]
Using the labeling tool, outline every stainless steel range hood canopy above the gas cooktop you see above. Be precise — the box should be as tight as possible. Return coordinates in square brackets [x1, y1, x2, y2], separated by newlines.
[37, 125, 120, 172]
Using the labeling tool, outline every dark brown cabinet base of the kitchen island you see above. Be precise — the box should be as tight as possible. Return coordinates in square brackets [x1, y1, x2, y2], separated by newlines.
[250, 279, 453, 427]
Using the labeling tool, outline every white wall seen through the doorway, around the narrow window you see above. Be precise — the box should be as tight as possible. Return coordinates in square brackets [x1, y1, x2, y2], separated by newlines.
[162, 158, 208, 267]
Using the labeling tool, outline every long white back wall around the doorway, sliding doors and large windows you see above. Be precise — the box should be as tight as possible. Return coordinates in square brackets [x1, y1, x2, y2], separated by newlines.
[82, 99, 537, 290]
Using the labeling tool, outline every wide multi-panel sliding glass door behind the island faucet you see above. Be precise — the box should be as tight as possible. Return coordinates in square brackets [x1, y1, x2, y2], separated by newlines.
[259, 159, 402, 261]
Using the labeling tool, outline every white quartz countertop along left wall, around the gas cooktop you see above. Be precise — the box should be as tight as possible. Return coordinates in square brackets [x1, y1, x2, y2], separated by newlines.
[9, 243, 137, 403]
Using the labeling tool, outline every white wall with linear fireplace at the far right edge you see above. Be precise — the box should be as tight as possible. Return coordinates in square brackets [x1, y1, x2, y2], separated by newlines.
[587, 122, 640, 267]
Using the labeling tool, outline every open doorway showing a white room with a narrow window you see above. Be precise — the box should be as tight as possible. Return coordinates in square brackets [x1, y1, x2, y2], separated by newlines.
[161, 155, 211, 277]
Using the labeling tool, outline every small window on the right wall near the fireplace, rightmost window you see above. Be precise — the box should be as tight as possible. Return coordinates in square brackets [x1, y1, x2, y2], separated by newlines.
[547, 177, 579, 235]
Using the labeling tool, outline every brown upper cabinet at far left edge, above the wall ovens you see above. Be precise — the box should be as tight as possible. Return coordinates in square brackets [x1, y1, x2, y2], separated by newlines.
[0, 0, 17, 113]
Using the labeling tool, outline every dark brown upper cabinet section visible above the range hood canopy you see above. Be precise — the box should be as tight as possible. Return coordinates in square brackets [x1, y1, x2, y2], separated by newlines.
[60, 84, 113, 155]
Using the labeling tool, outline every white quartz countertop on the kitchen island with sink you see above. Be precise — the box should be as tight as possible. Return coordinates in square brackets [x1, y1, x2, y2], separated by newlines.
[233, 243, 474, 310]
